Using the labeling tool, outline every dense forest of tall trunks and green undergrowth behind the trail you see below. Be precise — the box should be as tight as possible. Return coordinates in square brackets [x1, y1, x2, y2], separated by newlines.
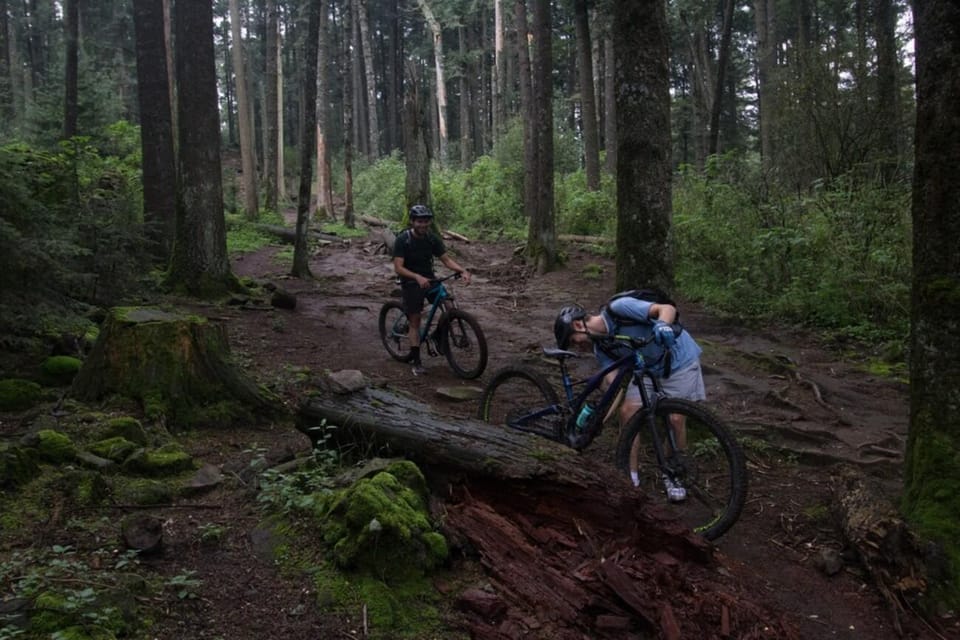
[0, 0, 960, 616]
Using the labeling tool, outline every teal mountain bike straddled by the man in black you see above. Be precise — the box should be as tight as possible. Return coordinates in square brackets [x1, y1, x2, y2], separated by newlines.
[379, 273, 487, 380]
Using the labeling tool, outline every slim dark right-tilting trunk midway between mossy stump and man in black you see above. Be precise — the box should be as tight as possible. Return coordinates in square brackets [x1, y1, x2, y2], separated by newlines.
[290, 2, 321, 278]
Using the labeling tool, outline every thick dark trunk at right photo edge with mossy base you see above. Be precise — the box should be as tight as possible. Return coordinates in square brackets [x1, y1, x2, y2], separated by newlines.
[903, 0, 960, 605]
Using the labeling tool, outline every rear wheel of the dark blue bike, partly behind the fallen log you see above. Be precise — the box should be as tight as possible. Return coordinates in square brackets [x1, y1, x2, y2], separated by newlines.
[477, 367, 566, 440]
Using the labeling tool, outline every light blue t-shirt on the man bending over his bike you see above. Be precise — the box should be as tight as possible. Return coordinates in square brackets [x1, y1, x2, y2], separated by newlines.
[593, 296, 702, 376]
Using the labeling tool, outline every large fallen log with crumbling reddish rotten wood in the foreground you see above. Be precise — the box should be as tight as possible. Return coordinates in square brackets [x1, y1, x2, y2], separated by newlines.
[298, 387, 798, 640]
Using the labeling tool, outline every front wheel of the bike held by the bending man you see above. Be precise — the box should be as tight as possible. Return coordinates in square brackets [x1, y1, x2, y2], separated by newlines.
[617, 398, 747, 540]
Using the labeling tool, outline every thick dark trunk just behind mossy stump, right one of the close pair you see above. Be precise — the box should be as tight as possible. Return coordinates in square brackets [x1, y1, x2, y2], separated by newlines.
[168, 0, 236, 297]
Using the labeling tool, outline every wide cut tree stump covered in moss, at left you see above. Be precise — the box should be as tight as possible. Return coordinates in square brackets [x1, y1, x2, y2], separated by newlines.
[72, 307, 280, 428]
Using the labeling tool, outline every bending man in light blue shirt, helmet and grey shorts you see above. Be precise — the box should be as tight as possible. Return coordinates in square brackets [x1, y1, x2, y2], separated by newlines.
[554, 296, 706, 502]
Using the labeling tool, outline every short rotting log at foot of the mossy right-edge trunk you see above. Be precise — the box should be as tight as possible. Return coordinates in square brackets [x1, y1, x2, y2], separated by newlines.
[833, 467, 927, 630]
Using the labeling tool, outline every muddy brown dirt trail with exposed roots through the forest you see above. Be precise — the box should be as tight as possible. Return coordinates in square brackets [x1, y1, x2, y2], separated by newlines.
[212, 226, 960, 640]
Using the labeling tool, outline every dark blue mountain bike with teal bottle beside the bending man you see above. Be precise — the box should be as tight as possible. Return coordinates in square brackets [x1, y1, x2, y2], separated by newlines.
[478, 336, 748, 540]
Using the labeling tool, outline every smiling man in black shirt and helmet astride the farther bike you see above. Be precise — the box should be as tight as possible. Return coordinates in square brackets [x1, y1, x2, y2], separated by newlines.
[393, 204, 470, 376]
